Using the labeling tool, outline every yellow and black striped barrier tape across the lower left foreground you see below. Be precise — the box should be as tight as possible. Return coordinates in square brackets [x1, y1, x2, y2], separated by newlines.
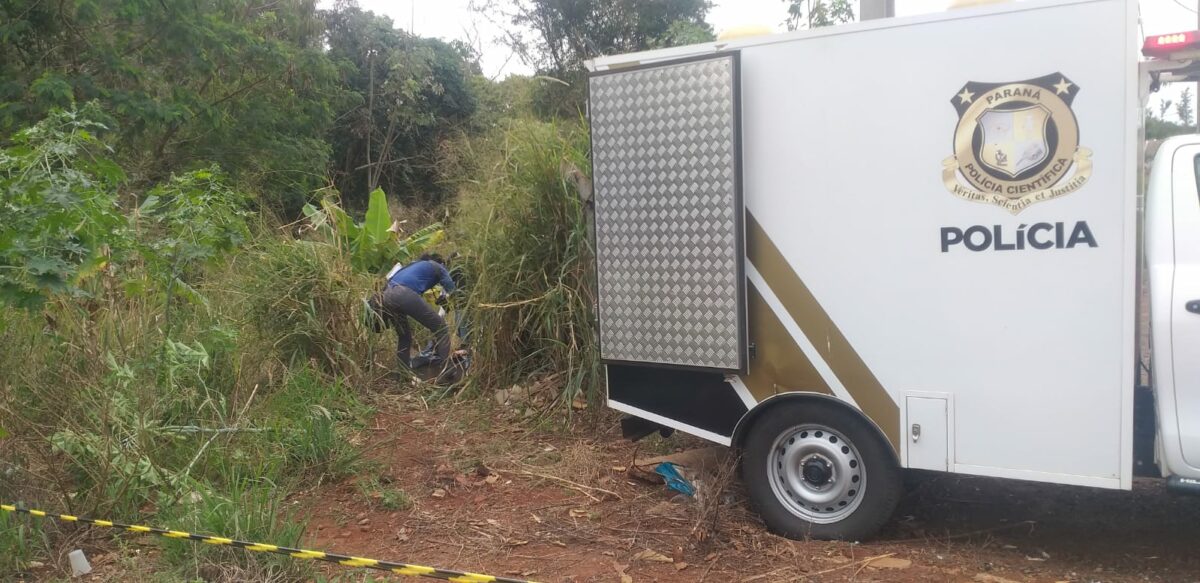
[0, 504, 533, 583]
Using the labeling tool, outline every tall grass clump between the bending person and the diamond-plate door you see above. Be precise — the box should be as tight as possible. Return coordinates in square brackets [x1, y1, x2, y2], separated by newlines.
[452, 120, 599, 403]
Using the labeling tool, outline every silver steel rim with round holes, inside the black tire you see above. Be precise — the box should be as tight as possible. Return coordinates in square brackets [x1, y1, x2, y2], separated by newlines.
[767, 423, 866, 524]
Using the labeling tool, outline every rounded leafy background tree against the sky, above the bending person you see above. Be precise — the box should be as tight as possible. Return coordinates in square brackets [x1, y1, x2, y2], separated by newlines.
[324, 2, 479, 208]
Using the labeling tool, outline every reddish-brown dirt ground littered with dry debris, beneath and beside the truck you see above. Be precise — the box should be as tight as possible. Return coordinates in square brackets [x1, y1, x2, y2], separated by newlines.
[293, 396, 1200, 583]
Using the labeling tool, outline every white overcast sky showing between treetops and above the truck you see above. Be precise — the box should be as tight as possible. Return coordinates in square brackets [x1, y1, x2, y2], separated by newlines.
[319, 0, 1200, 118]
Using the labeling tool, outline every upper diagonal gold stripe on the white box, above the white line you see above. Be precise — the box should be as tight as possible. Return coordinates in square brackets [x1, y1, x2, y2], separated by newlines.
[745, 212, 900, 451]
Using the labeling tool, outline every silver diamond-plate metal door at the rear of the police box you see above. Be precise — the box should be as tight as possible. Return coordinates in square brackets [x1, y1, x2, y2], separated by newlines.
[589, 53, 746, 371]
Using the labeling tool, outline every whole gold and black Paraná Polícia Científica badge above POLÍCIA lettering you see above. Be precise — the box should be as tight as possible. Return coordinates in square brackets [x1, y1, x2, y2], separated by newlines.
[942, 73, 1092, 215]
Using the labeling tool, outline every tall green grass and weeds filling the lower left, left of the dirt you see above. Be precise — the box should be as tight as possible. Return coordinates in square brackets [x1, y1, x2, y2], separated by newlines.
[0, 230, 373, 581]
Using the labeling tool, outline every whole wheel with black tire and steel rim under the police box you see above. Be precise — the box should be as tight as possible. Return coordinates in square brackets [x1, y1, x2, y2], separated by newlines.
[742, 399, 904, 541]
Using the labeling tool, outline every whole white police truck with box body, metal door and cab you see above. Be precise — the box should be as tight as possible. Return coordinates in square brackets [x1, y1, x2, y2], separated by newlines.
[589, 0, 1200, 539]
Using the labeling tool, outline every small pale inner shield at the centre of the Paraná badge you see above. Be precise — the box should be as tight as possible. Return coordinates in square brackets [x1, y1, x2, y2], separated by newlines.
[978, 103, 1050, 178]
